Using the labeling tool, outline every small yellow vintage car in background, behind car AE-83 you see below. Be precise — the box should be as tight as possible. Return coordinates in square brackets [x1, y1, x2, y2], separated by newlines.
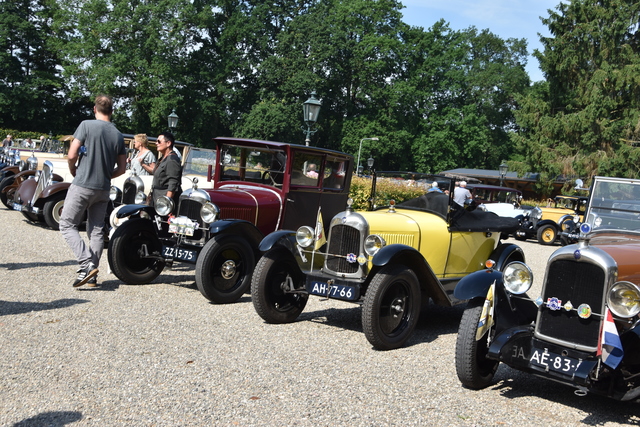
[515, 196, 589, 245]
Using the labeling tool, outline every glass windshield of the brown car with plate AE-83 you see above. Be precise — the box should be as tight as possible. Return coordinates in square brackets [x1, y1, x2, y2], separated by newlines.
[586, 177, 640, 231]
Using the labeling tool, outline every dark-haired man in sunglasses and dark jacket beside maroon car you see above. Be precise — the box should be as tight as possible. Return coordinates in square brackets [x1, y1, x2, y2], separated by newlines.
[150, 132, 182, 206]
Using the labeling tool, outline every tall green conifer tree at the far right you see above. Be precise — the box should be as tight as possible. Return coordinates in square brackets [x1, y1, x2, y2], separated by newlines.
[516, 0, 640, 183]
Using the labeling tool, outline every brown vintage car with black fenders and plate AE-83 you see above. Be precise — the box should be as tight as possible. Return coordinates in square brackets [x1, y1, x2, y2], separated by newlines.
[454, 177, 640, 401]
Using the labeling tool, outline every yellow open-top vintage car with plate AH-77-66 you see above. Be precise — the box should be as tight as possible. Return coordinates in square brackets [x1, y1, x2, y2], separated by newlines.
[251, 176, 524, 350]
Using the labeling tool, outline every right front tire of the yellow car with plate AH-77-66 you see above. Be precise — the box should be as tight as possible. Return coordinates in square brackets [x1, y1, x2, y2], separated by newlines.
[362, 265, 421, 350]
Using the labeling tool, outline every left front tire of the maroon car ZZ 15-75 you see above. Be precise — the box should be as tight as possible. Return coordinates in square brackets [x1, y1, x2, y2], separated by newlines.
[107, 218, 165, 285]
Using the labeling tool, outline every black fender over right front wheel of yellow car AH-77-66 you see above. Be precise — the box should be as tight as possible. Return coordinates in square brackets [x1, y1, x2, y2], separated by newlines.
[368, 244, 453, 306]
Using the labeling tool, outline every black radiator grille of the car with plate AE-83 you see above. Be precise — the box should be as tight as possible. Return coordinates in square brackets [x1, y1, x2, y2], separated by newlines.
[537, 260, 605, 348]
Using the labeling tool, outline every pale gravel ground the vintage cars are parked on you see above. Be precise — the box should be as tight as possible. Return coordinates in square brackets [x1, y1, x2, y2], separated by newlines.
[0, 209, 640, 426]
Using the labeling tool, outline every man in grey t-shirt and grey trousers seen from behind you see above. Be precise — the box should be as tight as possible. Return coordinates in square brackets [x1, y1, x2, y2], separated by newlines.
[60, 95, 127, 287]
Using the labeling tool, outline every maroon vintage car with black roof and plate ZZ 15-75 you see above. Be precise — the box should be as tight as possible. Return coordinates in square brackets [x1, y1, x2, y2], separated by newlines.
[108, 138, 353, 303]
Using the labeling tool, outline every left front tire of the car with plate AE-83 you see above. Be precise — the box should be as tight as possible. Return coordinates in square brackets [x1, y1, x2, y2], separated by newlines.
[456, 298, 500, 390]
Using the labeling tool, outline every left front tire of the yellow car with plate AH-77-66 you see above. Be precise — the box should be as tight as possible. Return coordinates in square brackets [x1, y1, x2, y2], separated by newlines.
[251, 249, 309, 323]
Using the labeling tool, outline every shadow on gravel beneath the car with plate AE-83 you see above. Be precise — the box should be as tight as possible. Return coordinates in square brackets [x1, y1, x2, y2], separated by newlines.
[492, 374, 640, 426]
